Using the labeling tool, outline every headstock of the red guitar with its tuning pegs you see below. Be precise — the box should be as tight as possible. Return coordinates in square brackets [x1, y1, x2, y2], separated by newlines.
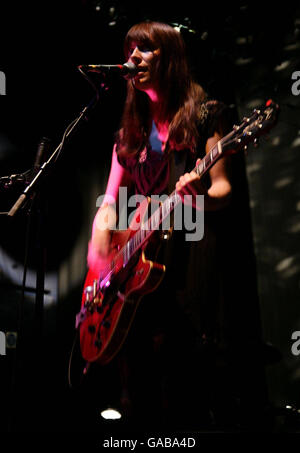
[221, 99, 279, 153]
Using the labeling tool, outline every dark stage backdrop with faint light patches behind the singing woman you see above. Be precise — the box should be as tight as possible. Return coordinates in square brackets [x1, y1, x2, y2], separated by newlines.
[0, 0, 300, 432]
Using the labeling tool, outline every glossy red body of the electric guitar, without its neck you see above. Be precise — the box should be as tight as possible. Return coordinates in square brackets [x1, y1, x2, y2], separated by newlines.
[79, 200, 165, 365]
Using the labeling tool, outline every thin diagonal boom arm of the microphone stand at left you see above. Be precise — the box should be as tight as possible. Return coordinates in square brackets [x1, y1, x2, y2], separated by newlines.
[7, 95, 98, 217]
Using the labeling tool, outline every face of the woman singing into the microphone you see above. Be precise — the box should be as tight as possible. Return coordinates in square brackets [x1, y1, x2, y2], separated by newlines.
[129, 41, 160, 92]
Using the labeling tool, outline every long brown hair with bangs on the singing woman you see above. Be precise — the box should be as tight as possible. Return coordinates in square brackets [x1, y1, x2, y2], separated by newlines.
[119, 21, 205, 154]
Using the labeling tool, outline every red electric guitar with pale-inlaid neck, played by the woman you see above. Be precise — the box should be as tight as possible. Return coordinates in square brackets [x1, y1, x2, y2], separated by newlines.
[76, 100, 279, 365]
